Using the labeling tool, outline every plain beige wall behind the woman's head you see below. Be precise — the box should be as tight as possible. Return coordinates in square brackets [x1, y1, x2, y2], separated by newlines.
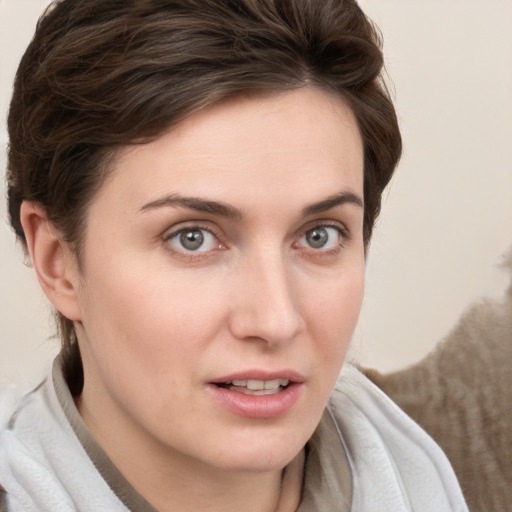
[0, 0, 512, 382]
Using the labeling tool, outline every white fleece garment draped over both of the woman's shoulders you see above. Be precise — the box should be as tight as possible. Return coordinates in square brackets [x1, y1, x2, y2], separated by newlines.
[0, 365, 468, 512]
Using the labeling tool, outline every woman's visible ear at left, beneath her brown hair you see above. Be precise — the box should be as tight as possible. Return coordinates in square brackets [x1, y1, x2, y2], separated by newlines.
[20, 201, 81, 322]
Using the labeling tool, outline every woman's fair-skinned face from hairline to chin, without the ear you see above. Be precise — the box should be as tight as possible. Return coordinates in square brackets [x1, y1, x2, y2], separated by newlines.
[77, 88, 364, 471]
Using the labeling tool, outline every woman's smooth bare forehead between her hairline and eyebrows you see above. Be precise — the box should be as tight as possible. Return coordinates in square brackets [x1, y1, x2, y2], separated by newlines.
[93, 88, 363, 215]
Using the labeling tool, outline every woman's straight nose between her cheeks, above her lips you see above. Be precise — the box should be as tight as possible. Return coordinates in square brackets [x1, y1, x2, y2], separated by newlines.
[230, 251, 304, 347]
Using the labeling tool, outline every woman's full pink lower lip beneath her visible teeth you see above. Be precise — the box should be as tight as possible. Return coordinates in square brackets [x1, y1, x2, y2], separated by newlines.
[208, 382, 302, 419]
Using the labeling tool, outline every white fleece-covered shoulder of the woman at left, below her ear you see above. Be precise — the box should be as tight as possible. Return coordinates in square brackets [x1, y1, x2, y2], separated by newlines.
[0, 360, 146, 512]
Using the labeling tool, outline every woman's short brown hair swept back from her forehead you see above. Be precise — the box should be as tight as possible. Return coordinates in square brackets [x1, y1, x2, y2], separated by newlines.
[7, 0, 401, 384]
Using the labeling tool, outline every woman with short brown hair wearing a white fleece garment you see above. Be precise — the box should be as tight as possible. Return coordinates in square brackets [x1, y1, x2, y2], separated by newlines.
[0, 0, 466, 512]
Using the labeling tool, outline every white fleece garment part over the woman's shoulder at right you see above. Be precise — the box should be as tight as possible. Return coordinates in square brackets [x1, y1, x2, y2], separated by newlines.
[328, 364, 467, 512]
